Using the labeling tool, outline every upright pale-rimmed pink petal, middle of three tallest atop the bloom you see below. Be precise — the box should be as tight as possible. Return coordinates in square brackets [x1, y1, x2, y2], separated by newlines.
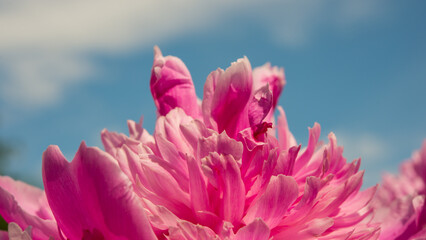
[202, 58, 253, 137]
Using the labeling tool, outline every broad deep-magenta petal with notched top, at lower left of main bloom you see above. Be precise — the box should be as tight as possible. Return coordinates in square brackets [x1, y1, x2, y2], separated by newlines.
[43, 143, 155, 239]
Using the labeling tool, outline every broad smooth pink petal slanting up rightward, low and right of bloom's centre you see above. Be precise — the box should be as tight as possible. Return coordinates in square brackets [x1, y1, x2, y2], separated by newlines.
[243, 175, 299, 229]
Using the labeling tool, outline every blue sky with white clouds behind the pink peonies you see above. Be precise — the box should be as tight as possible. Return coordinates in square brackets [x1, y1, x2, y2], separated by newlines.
[0, 0, 426, 186]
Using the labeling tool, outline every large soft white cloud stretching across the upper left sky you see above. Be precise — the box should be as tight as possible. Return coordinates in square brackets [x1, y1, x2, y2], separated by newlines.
[0, 0, 386, 108]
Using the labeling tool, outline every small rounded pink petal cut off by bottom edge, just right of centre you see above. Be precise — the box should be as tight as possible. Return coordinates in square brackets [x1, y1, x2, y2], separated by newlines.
[235, 218, 271, 240]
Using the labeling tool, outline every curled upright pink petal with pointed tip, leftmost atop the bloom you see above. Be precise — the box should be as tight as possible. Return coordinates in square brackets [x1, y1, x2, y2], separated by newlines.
[150, 46, 200, 118]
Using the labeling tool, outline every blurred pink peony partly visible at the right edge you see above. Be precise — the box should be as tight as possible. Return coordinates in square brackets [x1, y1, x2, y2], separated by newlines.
[371, 140, 426, 240]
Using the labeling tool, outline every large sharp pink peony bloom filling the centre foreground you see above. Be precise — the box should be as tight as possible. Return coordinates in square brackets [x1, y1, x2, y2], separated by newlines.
[0, 47, 380, 240]
